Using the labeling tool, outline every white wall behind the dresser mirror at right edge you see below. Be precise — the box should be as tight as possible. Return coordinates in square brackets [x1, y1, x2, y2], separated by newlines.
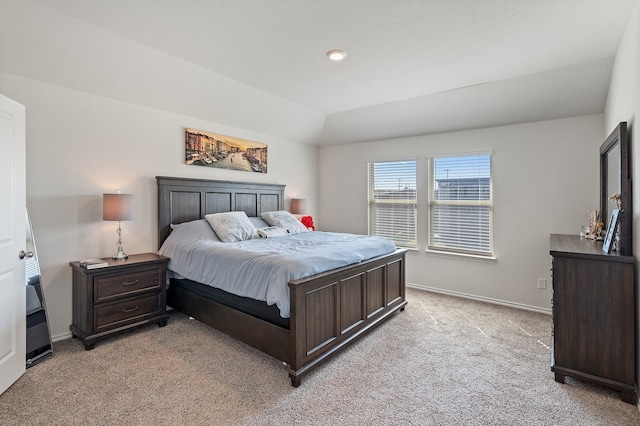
[604, 3, 640, 400]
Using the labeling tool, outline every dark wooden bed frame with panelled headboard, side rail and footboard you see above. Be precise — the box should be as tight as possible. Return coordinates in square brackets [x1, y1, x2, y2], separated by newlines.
[156, 176, 407, 387]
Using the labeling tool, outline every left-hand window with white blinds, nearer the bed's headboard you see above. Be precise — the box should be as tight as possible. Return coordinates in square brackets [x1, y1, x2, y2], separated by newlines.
[369, 160, 418, 248]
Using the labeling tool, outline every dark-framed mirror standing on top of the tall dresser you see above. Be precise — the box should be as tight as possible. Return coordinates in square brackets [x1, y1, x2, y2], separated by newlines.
[600, 122, 632, 255]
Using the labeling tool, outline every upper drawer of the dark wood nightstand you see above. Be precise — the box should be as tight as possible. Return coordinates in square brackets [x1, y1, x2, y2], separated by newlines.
[93, 267, 164, 303]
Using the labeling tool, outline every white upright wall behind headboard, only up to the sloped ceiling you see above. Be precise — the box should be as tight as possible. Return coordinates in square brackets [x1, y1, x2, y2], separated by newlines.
[0, 73, 317, 338]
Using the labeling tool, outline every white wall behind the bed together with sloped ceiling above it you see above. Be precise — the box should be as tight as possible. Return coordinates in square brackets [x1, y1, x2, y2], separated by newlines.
[0, 0, 324, 338]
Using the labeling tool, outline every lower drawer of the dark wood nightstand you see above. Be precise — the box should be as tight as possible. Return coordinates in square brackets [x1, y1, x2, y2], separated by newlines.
[94, 292, 162, 332]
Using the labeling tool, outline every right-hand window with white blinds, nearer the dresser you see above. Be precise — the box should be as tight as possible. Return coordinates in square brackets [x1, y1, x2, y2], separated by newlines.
[429, 154, 493, 256]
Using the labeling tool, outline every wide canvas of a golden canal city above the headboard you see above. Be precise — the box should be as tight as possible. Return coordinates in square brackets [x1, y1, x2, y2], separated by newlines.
[185, 129, 268, 173]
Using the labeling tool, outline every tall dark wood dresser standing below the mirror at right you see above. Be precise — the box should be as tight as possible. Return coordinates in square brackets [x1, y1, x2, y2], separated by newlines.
[550, 234, 637, 403]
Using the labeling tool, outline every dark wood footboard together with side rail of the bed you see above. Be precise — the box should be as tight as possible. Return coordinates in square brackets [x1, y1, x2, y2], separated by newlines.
[167, 250, 407, 387]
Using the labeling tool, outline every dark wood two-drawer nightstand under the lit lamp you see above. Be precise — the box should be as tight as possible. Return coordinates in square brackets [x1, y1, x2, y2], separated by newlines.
[69, 253, 169, 350]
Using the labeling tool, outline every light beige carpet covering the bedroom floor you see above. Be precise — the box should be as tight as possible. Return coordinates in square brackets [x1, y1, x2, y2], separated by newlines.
[0, 289, 640, 425]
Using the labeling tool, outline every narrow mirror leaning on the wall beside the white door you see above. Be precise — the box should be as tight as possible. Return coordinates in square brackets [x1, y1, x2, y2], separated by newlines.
[24, 209, 53, 368]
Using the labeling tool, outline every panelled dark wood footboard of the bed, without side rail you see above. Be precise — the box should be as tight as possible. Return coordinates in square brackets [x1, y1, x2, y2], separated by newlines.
[289, 250, 407, 386]
